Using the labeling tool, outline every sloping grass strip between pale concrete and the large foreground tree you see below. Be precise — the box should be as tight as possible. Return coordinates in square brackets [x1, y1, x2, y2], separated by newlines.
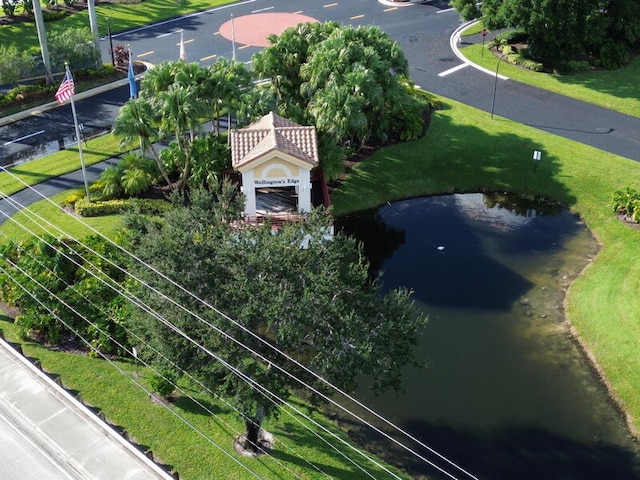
[0, 315, 408, 480]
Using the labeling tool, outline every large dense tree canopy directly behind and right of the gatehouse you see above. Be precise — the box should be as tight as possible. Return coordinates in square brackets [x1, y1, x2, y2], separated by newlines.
[253, 22, 424, 177]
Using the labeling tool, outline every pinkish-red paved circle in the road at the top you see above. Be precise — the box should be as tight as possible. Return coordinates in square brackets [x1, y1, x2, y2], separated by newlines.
[220, 12, 318, 47]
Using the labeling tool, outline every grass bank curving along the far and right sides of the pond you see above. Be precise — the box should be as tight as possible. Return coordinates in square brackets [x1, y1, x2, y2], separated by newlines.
[332, 100, 640, 431]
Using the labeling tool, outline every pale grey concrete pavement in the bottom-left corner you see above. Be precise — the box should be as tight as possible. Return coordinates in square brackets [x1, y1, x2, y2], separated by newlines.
[0, 340, 173, 480]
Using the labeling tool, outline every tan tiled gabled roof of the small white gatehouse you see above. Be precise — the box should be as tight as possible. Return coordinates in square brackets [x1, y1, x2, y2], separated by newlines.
[230, 112, 318, 168]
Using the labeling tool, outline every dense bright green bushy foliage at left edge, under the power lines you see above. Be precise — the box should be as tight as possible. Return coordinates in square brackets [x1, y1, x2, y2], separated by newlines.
[0, 235, 127, 353]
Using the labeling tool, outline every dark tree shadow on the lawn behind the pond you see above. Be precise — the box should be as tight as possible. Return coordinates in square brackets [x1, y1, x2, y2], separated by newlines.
[334, 108, 576, 215]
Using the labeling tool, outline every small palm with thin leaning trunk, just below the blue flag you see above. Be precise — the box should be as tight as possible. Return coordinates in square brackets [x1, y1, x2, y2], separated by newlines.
[113, 97, 171, 186]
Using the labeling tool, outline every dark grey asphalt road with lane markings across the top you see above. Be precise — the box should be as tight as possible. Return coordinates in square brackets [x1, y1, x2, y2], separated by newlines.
[0, 0, 640, 161]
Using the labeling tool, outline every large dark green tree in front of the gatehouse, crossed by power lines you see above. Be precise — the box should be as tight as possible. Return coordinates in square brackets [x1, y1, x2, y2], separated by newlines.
[127, 192, 425, 448]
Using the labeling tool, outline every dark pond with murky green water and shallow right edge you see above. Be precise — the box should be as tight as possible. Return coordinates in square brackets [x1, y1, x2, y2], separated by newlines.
[336, 194, 640, 480]
